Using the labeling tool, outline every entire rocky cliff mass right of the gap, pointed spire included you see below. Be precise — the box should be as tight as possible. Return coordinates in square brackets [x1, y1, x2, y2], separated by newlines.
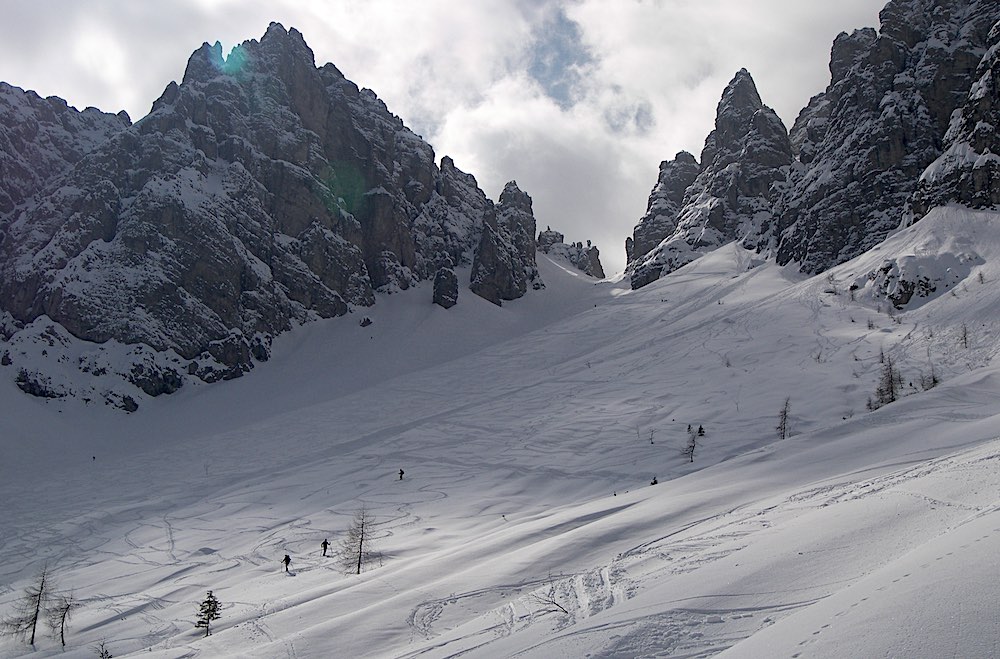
[626, 0, 998, 287]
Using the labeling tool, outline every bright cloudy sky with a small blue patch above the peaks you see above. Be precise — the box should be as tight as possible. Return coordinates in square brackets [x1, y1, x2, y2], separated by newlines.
[0, 0, 885, 274]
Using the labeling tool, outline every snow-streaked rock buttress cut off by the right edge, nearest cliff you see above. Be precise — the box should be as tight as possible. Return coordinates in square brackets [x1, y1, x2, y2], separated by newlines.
[904, 15, 1000, 224]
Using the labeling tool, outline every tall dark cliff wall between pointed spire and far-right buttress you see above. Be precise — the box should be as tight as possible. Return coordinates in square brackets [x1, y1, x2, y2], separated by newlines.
[775, 0, 997, 273]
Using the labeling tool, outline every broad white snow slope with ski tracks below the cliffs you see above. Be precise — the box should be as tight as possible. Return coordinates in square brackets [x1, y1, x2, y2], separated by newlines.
[0, 208, 1000, 658]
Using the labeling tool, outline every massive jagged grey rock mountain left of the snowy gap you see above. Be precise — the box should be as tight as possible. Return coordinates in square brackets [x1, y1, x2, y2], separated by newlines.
[0, 24, 538, 404]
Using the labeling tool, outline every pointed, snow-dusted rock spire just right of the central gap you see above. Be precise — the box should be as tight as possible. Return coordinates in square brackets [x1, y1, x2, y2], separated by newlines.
[626, 69, 792, 288]
